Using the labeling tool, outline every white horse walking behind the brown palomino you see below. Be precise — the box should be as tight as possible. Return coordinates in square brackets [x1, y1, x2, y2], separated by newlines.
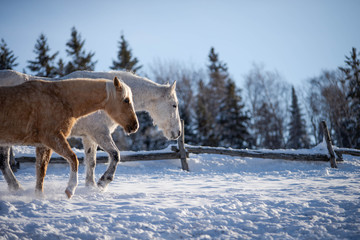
[0, 70, 181, 188]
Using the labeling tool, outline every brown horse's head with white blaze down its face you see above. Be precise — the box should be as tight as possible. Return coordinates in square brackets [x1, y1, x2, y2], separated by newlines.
[105, 77, 139, 134]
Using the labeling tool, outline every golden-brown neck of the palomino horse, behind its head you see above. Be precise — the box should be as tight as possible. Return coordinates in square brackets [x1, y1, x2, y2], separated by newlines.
[56, 80, 107, 118]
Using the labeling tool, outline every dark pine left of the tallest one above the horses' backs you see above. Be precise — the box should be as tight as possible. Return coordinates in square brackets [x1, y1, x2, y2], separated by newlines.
[27, 34, 59, 77]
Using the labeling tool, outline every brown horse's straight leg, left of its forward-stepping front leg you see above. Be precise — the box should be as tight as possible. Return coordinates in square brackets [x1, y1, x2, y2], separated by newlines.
[35, 147, 52, 195]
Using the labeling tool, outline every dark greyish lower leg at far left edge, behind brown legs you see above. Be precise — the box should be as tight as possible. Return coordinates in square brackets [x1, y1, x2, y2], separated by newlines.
[0, 147, 21, 191]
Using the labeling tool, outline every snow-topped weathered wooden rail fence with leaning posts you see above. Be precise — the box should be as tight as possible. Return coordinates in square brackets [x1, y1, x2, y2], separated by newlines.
[16, 120, 360, 171]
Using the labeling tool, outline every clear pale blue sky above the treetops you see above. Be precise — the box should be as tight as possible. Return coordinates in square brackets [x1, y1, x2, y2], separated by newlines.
[0, 0, 360, 86]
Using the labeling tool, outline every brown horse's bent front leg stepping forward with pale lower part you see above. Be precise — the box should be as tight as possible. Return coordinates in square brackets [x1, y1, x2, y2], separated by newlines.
[47, 134, 79, 198]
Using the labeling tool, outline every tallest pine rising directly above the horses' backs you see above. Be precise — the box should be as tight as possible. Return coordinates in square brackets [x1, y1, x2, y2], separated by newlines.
[64, 27, 96, 74]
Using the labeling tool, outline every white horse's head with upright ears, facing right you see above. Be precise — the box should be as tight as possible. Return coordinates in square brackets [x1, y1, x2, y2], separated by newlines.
[151, 81, 181, 140]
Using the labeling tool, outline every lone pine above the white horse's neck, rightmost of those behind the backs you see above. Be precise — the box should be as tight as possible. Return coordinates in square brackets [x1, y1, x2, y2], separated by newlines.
[110, 35, 142, 73]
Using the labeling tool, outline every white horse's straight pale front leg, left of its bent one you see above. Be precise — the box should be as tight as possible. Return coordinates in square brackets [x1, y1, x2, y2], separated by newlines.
[83, 137, 98, 187]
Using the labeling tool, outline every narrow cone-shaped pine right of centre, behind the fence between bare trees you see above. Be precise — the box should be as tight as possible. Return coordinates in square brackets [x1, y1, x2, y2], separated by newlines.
[288, 87, 310, 149]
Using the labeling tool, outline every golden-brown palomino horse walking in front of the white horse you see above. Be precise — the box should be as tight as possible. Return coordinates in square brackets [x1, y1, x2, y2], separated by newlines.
[0, 77, 138, 198]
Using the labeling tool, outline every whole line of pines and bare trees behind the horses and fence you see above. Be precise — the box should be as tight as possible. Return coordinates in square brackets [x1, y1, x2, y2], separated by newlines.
[0, 27, 360, 150]
